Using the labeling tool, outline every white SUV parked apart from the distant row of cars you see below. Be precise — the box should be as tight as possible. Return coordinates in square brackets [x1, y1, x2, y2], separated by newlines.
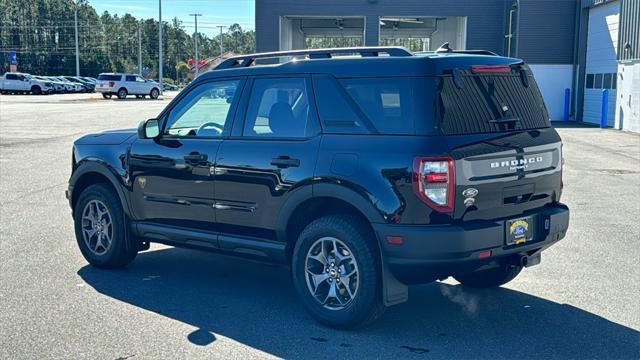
[96, 73, 160, 99]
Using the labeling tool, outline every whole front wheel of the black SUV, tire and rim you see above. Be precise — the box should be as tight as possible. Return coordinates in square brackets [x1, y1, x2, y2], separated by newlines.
[73, 184, 138, 269]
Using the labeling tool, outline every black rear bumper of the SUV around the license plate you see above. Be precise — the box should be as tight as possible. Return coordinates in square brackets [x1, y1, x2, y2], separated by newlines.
[374, 204, 569, 284]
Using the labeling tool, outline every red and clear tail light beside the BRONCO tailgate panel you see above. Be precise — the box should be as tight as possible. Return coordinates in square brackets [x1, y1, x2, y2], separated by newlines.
[413, 157, 455, 212]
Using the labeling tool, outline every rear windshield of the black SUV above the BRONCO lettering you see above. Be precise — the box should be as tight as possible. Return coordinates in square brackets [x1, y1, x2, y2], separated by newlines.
[435, 70, 551, 134]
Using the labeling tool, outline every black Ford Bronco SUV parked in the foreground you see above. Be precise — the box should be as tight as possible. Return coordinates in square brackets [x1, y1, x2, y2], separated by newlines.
[67, 47, 569, 327]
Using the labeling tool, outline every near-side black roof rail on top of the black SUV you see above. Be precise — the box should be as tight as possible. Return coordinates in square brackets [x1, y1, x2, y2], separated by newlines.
[215, 46, 413, 70]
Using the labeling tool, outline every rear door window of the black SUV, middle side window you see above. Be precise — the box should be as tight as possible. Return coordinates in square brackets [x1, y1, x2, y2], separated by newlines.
[243, 78, 313, 138]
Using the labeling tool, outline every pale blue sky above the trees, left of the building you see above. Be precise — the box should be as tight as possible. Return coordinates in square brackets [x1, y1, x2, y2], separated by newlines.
[89, 0, 255, 36]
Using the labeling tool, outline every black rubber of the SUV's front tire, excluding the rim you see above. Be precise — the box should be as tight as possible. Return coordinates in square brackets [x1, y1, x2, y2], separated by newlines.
[73, 184, 138, 269]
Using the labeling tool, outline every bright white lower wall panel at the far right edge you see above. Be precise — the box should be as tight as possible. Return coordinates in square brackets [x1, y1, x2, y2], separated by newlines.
[615, 61, 640, 132]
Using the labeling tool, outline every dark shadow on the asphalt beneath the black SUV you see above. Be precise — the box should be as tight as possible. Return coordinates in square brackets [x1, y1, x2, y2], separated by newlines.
[78, 248, 640, 358]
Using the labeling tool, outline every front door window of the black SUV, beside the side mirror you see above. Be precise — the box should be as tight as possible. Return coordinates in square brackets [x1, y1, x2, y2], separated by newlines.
[164, 80, 241, 137]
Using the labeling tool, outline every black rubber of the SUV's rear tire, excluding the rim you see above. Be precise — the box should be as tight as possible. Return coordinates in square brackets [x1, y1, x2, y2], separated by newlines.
[291, 215, 385, 328]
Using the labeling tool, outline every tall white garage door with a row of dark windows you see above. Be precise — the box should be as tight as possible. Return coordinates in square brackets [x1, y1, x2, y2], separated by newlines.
[582, 1, 620, 126]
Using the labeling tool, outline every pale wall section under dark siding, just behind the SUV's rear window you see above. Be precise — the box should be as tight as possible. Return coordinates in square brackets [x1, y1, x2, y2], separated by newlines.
[529, 64, 573, 121]
